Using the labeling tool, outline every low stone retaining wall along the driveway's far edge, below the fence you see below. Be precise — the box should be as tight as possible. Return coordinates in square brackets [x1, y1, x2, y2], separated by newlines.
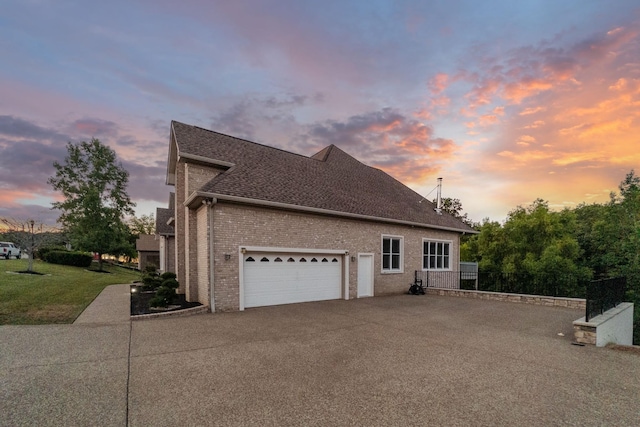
[425, 288, 586, 310]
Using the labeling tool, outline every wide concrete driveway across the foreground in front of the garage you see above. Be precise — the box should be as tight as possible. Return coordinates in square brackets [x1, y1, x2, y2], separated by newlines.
[0, 288, 640, 426]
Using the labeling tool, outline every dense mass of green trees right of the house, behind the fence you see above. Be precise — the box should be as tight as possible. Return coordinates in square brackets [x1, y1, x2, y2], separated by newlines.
[454, 170, 640, 344]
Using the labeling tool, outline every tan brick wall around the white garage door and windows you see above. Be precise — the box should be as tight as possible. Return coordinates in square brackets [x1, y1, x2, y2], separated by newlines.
[213, 203, 459, 311]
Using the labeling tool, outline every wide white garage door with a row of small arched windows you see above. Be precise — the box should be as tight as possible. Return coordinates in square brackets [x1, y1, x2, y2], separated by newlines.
[244, 252, 342, 307]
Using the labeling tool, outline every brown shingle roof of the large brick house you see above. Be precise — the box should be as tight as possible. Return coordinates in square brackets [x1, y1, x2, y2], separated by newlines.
[172, 121, 473, 232]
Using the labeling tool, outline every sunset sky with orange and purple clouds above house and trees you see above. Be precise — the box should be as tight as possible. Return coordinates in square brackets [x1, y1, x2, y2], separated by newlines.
[0, 0, 640, 229]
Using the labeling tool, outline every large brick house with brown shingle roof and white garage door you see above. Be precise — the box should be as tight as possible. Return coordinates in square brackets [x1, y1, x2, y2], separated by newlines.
[166, 121, 474, 311]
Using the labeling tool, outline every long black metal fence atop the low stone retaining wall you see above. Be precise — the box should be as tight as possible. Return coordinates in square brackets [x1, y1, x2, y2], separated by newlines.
[415, 270, 588, 298]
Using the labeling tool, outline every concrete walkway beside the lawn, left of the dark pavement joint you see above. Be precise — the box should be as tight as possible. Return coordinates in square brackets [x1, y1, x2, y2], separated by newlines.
[0, 285, 131, 426]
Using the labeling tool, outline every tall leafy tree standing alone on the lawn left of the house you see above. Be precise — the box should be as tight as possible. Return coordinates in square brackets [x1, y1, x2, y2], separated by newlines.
[48, 138, 135, 270]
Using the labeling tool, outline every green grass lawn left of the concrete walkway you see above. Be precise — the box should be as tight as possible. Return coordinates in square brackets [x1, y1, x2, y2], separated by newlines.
[0, 259, 140, 325]
